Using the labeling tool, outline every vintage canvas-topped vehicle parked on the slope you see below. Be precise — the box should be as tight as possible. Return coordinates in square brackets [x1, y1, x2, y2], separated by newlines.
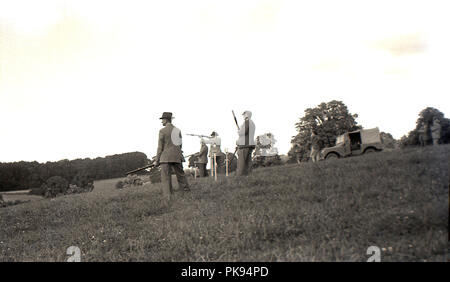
[320, 128, 384, 160]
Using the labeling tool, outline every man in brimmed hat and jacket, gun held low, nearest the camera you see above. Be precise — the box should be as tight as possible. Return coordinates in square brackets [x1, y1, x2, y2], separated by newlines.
[155, 112, 190, 203]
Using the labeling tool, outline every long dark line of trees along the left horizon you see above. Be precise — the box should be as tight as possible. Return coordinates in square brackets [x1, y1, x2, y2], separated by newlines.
[0, 152, 149, 191]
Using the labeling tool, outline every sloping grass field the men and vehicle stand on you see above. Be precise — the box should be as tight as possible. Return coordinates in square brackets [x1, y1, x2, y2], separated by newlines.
[0, 146, 450, 261]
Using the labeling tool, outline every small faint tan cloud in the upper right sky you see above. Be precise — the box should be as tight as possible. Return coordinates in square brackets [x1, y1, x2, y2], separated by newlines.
[374, 33, 427, 56]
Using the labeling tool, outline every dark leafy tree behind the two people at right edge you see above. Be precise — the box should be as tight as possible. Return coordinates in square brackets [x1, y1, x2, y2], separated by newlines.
[400, 107, 450, 147]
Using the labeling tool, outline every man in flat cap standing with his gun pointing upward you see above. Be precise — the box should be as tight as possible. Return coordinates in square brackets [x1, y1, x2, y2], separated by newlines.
[236, 111, 256, 176]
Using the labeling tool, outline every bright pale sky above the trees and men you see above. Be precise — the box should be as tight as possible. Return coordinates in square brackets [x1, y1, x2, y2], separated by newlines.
[0, 0, 450, 162]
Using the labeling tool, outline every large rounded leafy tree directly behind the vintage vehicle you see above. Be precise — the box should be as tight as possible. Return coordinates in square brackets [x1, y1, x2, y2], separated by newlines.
[288, 100, 361, 161]
